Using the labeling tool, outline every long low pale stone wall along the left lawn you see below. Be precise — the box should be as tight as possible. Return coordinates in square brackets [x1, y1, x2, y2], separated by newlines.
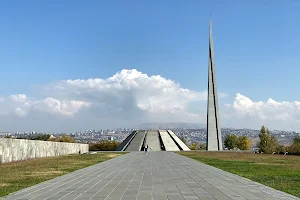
[0, 138, 89, 163]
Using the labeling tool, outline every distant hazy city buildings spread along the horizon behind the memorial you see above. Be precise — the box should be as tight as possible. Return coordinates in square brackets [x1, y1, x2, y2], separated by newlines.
[0, 127, 299, 148]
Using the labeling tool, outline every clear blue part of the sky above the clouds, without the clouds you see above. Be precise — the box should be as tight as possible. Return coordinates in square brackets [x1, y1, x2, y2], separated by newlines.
[0, 0, 300, 130]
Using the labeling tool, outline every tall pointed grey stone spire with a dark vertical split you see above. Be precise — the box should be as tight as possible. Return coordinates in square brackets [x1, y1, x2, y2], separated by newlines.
[206, 17, 223, 151]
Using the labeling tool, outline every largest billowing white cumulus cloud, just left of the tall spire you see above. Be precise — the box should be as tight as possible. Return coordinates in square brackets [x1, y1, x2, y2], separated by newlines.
[39, 69, 211, 123]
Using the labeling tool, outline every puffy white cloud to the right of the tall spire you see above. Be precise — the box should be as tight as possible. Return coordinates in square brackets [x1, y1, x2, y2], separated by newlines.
[222, 93, 300, 129]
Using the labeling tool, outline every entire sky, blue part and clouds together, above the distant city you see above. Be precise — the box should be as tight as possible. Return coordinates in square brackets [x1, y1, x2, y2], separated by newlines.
[0, 0, 300, 132]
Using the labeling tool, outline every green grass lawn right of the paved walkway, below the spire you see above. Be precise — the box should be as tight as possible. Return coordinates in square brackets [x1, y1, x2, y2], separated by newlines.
[179, 151, 300, 197]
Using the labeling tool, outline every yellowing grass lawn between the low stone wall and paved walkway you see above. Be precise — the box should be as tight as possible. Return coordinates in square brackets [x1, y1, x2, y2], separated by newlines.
[0, 152, 124, 197]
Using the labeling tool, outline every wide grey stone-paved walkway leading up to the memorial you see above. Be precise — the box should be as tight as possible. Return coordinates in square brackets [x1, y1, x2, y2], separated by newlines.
[5, 151, 299, 200]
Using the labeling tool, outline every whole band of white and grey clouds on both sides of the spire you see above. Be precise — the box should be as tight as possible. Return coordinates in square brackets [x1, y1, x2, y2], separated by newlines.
[0, 69, 300, 131]
